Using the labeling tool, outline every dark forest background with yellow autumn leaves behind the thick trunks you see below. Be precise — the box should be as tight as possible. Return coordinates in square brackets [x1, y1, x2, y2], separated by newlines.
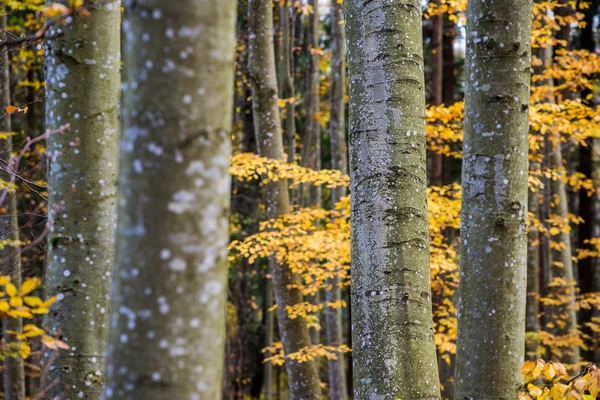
[0, 0, 600, 399]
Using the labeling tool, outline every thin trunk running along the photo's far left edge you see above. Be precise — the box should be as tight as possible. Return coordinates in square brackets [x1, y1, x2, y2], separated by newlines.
[0, 10, 25, 400]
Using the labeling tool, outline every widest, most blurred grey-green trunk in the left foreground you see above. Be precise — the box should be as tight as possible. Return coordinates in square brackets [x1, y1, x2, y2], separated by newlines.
[104, 0, 236, 400]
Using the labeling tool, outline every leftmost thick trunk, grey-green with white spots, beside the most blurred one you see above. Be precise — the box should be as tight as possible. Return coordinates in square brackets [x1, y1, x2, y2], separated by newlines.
[44, 0, 121, 399]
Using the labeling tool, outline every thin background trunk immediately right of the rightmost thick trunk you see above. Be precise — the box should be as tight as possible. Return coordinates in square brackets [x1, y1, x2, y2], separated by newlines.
[525, 175, 541, 361]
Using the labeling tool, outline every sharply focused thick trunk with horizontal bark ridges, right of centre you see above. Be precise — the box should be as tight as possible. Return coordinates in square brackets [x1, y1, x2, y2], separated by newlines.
[344, 0, 440, 400]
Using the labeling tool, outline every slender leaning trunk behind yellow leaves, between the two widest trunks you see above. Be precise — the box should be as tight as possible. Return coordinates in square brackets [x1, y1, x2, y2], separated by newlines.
[248, 0, 321, 400]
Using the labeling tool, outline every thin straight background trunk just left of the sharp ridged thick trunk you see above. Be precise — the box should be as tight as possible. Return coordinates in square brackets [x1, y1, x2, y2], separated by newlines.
[324, 0, 348, 400]
